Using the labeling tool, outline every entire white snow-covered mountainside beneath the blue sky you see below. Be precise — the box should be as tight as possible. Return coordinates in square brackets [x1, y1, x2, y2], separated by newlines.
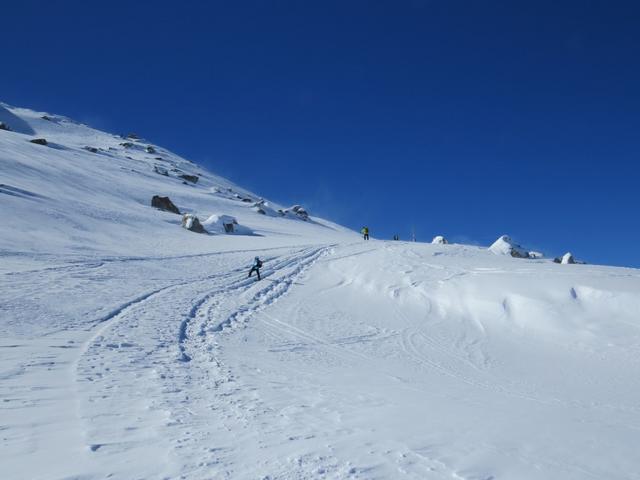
[0, 102, 640, 480]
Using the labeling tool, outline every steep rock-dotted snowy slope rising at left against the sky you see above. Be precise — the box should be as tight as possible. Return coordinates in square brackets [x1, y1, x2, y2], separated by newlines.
[0, 105, 354, 255]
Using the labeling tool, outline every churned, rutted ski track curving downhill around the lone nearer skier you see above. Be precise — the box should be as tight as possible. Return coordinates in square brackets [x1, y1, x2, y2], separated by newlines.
[74, 246, 332, 475]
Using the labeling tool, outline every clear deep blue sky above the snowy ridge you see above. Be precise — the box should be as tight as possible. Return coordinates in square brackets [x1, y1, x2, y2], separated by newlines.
[0, 0, 640, 267]
